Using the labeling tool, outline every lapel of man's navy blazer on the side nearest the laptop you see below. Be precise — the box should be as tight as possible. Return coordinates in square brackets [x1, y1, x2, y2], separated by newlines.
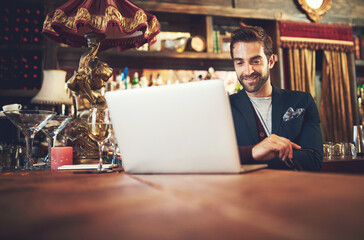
[230, 90, 259, 142]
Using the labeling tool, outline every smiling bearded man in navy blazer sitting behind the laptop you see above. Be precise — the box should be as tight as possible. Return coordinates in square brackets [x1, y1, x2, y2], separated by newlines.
[230, 26, 323, 171]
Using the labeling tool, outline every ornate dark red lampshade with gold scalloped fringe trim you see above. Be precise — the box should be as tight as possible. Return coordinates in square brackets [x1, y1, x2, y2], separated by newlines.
[43, 0, 160, 51]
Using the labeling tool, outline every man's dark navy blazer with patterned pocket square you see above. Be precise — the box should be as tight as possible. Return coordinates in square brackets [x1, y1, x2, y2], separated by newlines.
[230, 86, 323, 171]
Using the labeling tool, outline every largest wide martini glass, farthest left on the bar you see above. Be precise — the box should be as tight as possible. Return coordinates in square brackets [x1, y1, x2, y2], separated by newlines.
[4, 110, 56, 170]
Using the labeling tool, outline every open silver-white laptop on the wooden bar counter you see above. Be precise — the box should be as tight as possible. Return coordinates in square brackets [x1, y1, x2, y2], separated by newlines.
[105, 80, 266, 173]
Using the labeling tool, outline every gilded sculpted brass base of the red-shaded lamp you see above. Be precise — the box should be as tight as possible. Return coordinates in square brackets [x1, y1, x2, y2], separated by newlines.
[67, 33, 113, 162]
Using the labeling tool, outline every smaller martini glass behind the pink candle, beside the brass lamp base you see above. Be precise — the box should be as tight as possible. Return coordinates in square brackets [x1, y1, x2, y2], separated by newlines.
[42, 115, 72, 167]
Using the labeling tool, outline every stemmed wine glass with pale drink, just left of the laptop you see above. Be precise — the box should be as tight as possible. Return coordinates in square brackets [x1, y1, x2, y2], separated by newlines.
[87, 108, 111, 172]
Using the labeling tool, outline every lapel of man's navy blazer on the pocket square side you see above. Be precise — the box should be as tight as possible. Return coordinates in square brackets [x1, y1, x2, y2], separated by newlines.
[272, 85, 286, 134]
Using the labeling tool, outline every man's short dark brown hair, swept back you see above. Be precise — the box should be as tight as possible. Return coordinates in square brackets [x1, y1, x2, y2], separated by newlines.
[230, 26, 273, 59]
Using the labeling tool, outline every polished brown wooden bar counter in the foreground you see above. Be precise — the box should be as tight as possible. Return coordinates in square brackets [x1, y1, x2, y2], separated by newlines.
[0, 169, 364, 240]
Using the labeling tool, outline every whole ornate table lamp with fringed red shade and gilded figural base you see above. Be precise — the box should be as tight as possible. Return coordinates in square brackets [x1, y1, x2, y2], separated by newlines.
[42, 0, 160, 163]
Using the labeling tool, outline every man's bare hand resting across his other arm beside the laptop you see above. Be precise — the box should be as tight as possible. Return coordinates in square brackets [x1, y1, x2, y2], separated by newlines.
[252, 134, 301, 161]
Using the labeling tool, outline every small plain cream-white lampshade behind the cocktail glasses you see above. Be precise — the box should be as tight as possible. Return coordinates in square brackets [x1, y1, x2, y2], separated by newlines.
[30, 70, 72, 105]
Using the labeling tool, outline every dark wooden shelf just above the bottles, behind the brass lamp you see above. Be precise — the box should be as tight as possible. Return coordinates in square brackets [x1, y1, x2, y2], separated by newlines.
[57, 47, 234, 71]
